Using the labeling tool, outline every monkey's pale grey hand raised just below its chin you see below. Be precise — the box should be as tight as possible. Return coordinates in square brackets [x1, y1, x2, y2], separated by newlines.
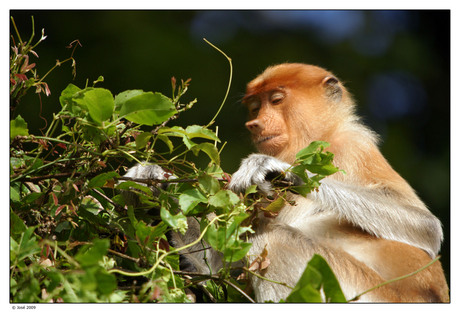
[229, 154, 303, 195]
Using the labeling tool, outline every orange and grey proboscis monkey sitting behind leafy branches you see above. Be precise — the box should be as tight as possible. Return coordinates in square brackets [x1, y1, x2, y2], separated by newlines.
[124, 64, 449, 302]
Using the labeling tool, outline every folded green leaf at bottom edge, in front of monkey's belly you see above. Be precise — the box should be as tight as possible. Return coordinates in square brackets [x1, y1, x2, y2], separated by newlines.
[286, 254, 346, 303]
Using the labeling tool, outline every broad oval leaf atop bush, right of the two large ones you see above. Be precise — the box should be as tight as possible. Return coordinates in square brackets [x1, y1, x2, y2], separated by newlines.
[120, 92, 177, 126]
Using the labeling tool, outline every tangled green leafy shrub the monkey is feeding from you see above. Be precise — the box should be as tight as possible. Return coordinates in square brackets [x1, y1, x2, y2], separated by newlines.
[10, 16, 343, 302]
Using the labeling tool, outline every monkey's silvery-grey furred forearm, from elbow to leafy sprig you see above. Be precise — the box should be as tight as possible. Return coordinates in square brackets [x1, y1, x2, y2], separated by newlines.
[309, 178, 443, 258]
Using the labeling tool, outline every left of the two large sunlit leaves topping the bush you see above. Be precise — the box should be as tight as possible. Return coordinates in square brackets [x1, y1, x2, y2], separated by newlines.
[76, 88, 114, 125]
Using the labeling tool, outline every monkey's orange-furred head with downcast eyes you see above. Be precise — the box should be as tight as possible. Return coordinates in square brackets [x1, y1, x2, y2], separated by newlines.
[243, 63, 354, 162]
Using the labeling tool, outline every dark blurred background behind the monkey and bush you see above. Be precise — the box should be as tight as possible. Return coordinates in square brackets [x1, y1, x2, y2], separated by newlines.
[10, 10, 450, 277]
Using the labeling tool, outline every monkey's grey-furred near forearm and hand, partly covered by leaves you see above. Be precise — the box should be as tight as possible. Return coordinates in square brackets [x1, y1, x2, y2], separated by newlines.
[229, 154, 443, 257]
